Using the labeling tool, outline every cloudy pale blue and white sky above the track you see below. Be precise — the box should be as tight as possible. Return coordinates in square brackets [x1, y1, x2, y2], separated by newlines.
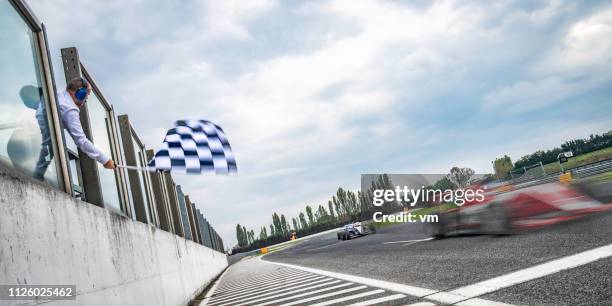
[28, 0, 612, 245]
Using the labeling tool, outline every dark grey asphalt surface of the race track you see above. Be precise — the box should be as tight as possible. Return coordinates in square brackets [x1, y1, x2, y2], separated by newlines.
[207, 213, 612, 305]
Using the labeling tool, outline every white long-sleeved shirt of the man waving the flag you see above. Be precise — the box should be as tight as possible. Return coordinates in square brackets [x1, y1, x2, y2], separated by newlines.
[57, 90, 110, 164]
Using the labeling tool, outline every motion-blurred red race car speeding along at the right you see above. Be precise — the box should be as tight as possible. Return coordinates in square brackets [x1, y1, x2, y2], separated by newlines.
[428, 183, 612, 238]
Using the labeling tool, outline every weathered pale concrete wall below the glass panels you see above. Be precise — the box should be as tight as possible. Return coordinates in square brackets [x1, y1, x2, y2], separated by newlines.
[0, 165, 228, 305]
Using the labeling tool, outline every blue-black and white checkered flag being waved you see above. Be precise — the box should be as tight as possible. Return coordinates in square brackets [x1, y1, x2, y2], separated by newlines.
[149, 120, 238, 174]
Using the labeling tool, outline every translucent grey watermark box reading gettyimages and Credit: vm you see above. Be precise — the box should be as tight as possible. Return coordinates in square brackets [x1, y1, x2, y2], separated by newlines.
[360, 175, 486, 223]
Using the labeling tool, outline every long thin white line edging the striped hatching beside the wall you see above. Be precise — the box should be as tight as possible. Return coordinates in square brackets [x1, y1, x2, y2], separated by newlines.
[259, 257, 438, 297]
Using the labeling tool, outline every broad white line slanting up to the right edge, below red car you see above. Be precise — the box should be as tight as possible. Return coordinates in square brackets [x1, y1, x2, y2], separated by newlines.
[427, 244, 612, 303]
